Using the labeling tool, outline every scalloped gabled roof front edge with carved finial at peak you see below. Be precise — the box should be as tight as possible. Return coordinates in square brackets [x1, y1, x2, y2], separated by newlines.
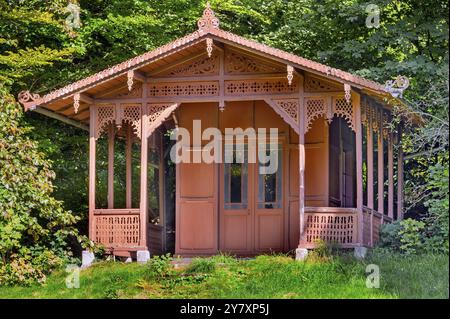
[19, 5, 403, 121]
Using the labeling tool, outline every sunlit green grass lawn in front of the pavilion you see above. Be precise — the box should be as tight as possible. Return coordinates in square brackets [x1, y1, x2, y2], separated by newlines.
[0, 252, 449, 298]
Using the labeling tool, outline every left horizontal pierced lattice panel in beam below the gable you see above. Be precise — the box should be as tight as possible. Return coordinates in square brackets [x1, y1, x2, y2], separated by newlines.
[149, 82, 219, 97]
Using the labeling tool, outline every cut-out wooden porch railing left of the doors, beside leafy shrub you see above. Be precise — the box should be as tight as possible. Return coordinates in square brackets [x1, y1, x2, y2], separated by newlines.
[91, 208, 141, 250]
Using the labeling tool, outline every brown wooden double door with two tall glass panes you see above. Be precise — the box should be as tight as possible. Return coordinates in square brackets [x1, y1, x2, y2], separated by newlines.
[219, 144, 285, 255]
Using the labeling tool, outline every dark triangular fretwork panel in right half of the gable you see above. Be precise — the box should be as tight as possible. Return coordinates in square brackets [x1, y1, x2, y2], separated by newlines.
[225, 50, 284, 74]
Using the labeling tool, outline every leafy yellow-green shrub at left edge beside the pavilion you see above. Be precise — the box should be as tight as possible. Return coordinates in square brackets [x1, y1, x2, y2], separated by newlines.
[0, 86, 89, 284]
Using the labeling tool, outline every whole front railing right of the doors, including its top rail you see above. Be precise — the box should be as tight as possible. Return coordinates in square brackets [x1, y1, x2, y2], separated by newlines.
[301, 207, 358, 248]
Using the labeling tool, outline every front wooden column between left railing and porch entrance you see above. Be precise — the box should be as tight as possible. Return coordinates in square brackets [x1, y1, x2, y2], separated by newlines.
[139, 82, 149, 249]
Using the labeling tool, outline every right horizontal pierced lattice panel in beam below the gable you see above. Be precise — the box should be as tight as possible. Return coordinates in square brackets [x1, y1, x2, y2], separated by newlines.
[225, 79, 298, 95]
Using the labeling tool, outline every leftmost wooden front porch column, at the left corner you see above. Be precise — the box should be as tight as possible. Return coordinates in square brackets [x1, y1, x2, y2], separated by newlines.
[89, 105, 97, 240]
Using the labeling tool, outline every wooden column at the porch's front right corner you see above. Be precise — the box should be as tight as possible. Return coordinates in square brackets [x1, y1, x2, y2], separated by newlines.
[352, 91, 363, 246]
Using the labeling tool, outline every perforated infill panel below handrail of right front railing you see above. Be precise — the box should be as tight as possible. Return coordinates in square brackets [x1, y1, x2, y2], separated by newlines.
[304, 213, 356, 244]
